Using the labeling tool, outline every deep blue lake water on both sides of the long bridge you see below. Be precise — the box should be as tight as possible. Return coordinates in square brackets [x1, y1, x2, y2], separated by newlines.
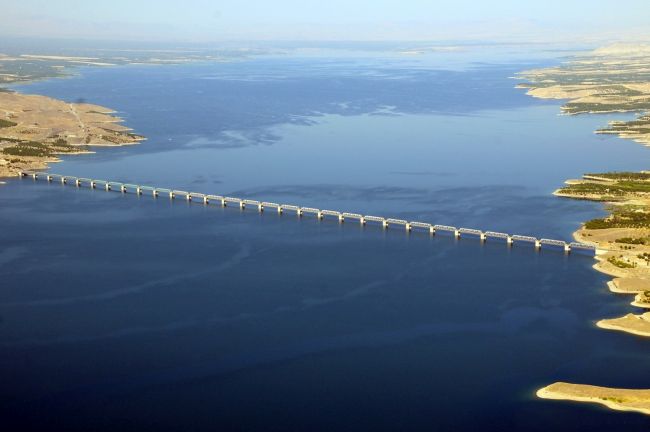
[0, 51, 650, 431]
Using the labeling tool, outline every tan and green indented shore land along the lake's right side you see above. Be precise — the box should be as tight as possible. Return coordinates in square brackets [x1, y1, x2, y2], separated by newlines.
[518, 44, 650, 414]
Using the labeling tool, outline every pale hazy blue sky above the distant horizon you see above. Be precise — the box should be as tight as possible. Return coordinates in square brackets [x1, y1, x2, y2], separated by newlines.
[0, 0, 650, 43]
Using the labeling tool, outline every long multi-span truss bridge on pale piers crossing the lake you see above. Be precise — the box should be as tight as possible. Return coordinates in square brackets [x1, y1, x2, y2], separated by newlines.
[20, 172, 596, 253]
